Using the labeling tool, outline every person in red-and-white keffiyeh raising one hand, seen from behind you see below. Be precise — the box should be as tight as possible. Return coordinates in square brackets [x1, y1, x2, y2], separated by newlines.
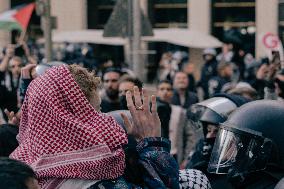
[10, 65, 210, 189]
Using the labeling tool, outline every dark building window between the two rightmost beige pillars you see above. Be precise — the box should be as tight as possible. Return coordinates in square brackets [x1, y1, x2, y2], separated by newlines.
[211, 0, 256, 53]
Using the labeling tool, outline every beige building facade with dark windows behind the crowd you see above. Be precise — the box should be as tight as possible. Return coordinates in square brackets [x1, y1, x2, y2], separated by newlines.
[0, 0, 284, 60]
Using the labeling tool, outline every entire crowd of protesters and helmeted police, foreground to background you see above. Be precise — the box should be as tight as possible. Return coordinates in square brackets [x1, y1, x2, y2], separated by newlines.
[0, 38, 284, 189]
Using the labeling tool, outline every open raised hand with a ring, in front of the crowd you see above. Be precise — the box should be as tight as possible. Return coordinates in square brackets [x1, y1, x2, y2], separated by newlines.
[121, 86, 161, 141]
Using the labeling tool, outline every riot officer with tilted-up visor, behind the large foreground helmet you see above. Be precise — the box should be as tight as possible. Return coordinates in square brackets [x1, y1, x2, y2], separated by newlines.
[187, 94, 248, 188]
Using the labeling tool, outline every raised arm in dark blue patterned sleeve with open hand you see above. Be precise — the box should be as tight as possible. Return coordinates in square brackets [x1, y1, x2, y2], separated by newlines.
[122, 87, 179, 189]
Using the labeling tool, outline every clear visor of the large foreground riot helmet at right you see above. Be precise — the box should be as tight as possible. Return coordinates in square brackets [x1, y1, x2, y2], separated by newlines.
[208, 126, 269, 174]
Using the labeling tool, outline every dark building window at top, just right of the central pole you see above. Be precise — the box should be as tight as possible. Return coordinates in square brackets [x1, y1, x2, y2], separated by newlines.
[148, 0, 187, 28]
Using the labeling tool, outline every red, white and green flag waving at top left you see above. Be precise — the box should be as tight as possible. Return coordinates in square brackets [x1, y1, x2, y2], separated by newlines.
[0, 3, 35, 31]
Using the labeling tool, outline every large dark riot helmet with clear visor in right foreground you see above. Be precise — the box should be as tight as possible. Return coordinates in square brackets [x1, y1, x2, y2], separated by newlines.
[208, 100, 284, 177]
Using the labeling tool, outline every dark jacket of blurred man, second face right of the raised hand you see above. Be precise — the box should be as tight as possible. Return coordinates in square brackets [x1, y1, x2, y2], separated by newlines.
[172, 91, 198, 109]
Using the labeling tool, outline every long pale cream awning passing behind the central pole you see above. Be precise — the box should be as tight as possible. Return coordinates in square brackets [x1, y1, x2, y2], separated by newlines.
[41, 28, 222, 48]
